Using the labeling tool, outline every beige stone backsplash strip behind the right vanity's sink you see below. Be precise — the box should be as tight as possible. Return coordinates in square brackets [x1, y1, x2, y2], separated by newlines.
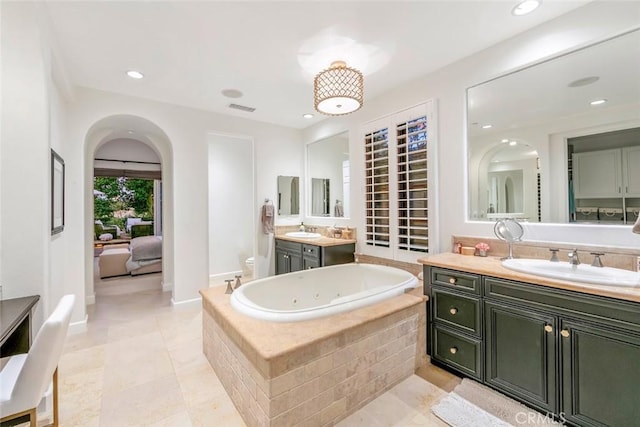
[451, 236, 640, 271]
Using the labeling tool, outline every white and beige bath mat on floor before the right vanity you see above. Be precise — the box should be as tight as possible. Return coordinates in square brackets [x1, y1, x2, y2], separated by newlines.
[432, 378, 562, 427]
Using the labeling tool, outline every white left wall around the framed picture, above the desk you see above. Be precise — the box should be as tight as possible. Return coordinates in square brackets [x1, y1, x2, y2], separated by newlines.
[0, 2, 77, 330]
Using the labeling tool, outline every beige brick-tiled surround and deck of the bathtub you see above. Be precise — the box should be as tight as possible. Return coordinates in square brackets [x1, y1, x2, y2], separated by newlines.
[201, 288, 425, 426]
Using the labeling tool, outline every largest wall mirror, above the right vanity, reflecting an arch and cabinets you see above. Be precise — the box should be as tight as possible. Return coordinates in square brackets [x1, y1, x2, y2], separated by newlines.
[467, 30, 640, 224]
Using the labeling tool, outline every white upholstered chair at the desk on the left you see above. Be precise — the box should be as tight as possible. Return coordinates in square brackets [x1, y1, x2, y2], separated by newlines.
[0, 295, 75, 427]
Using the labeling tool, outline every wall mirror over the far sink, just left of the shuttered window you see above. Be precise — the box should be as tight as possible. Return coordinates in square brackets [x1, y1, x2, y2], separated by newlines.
[307, 132, 350, 218]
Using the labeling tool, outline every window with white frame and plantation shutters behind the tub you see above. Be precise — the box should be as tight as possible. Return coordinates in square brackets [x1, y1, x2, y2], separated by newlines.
[363, 101, 435, 262]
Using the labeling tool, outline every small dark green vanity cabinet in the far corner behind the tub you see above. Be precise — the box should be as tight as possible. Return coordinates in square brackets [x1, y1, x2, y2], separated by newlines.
[275, 239, 356, 274]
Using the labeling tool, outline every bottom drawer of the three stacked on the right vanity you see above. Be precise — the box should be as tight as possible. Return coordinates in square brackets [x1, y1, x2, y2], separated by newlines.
[433, 325, 482, 380]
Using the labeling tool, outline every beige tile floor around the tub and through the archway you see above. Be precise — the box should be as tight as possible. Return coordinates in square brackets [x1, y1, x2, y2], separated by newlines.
[59, 274, 459, 427]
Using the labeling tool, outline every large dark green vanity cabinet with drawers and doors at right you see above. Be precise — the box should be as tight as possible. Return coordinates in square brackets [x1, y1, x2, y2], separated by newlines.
[424, 266, 640, 426]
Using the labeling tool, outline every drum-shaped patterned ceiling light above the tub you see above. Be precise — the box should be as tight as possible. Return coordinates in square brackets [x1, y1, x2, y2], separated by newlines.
[313, 61, 364, 116]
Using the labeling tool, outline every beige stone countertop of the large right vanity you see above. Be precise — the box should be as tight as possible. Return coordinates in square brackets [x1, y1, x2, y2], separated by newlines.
[418, 253, 640, 302]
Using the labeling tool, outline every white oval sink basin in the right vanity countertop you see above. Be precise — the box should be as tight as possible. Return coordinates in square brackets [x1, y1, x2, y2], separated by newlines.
[502, 258, 640, 286]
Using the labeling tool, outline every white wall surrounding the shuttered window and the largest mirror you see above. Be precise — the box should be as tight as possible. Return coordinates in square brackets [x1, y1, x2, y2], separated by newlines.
[304, 2, 640, 251]
